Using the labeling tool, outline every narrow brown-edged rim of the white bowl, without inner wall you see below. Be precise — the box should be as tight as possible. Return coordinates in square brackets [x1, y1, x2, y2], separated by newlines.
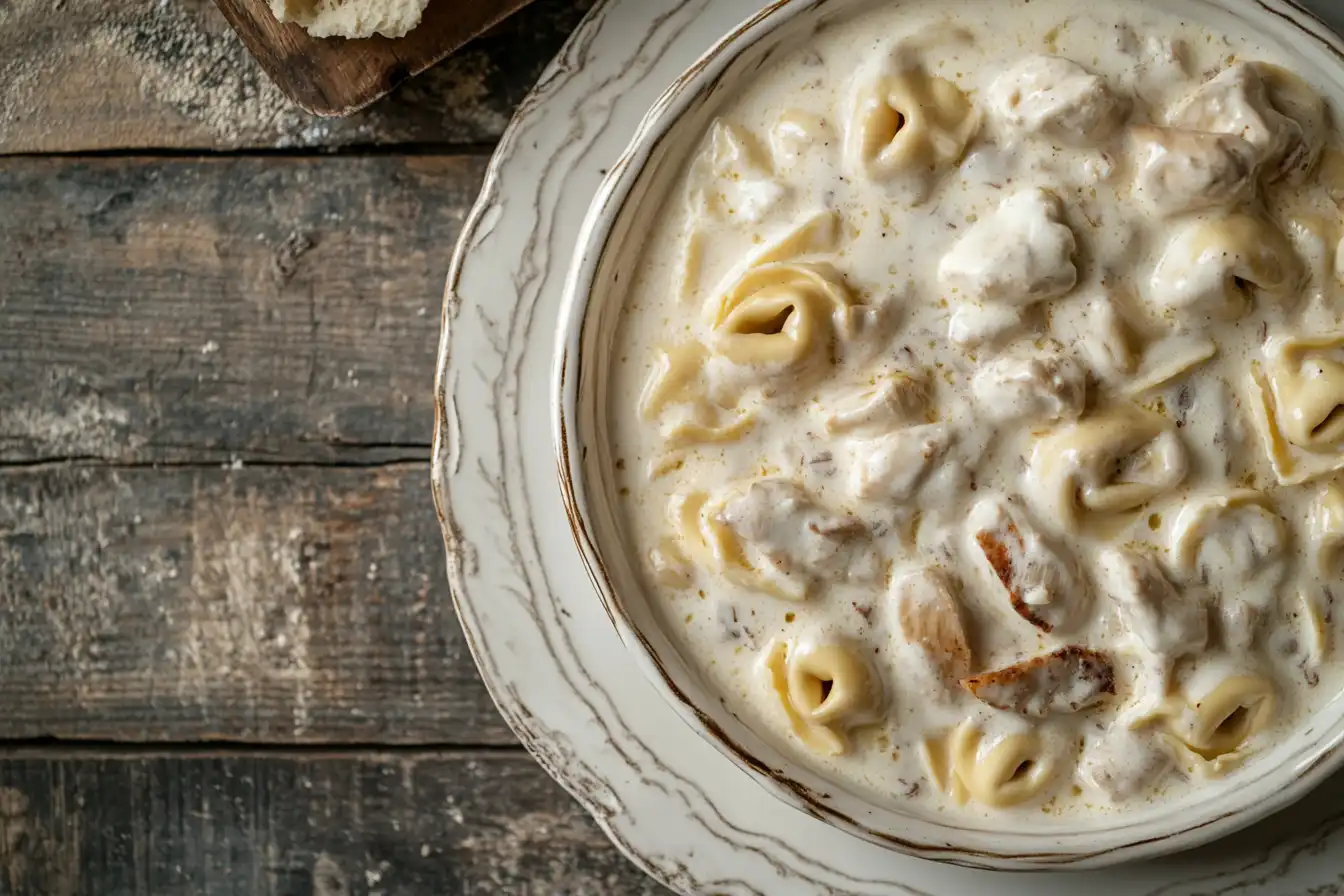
[550, 0, 1344, 870]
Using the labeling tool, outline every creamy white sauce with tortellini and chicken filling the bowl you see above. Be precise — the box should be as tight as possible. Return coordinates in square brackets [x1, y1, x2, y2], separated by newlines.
[610, 0, 1344, 813]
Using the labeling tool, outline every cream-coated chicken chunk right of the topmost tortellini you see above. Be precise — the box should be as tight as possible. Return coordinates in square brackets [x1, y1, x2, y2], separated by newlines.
[985, 56, 1124, 146]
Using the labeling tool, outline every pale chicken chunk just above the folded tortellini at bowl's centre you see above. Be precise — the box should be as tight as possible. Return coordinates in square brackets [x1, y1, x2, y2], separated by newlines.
[970, 353, 1087, 422]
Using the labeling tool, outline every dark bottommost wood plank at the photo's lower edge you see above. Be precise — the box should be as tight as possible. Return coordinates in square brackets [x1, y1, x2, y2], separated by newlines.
[0, 752, 665, 896]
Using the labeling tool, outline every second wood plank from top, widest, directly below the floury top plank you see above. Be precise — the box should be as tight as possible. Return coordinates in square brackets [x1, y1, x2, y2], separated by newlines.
[0, 155, 485, 462]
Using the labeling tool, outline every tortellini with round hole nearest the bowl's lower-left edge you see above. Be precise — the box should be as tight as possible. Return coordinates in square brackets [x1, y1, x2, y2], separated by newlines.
[762, 641, 882, 756]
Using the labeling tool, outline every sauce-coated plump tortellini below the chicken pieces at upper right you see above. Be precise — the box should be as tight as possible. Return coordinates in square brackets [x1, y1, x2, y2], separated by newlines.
[1145, 212, 1304, 326]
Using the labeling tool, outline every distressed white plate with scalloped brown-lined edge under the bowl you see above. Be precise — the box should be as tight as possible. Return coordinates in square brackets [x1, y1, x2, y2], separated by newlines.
[434, 0, 1344, 896]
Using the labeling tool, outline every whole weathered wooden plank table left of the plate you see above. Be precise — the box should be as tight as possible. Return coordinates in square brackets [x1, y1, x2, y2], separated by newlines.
[0, 0, 659, 896]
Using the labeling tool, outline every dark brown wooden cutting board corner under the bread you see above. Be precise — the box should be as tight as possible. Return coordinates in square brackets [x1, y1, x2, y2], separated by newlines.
[215, 0, 531, 116]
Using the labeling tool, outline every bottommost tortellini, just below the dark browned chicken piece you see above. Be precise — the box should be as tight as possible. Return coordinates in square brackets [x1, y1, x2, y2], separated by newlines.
[925, 719, 1058, 809]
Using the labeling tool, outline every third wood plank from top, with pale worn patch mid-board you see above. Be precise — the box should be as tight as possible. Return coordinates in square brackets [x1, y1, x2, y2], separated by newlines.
[0, 463, 515, 744]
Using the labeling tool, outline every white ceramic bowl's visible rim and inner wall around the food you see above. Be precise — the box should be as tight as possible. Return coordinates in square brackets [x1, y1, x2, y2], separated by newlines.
[554, 0, 1344, 869]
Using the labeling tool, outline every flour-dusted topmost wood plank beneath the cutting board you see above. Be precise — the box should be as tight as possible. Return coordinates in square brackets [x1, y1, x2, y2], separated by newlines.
[0, 0, 593, 153]
